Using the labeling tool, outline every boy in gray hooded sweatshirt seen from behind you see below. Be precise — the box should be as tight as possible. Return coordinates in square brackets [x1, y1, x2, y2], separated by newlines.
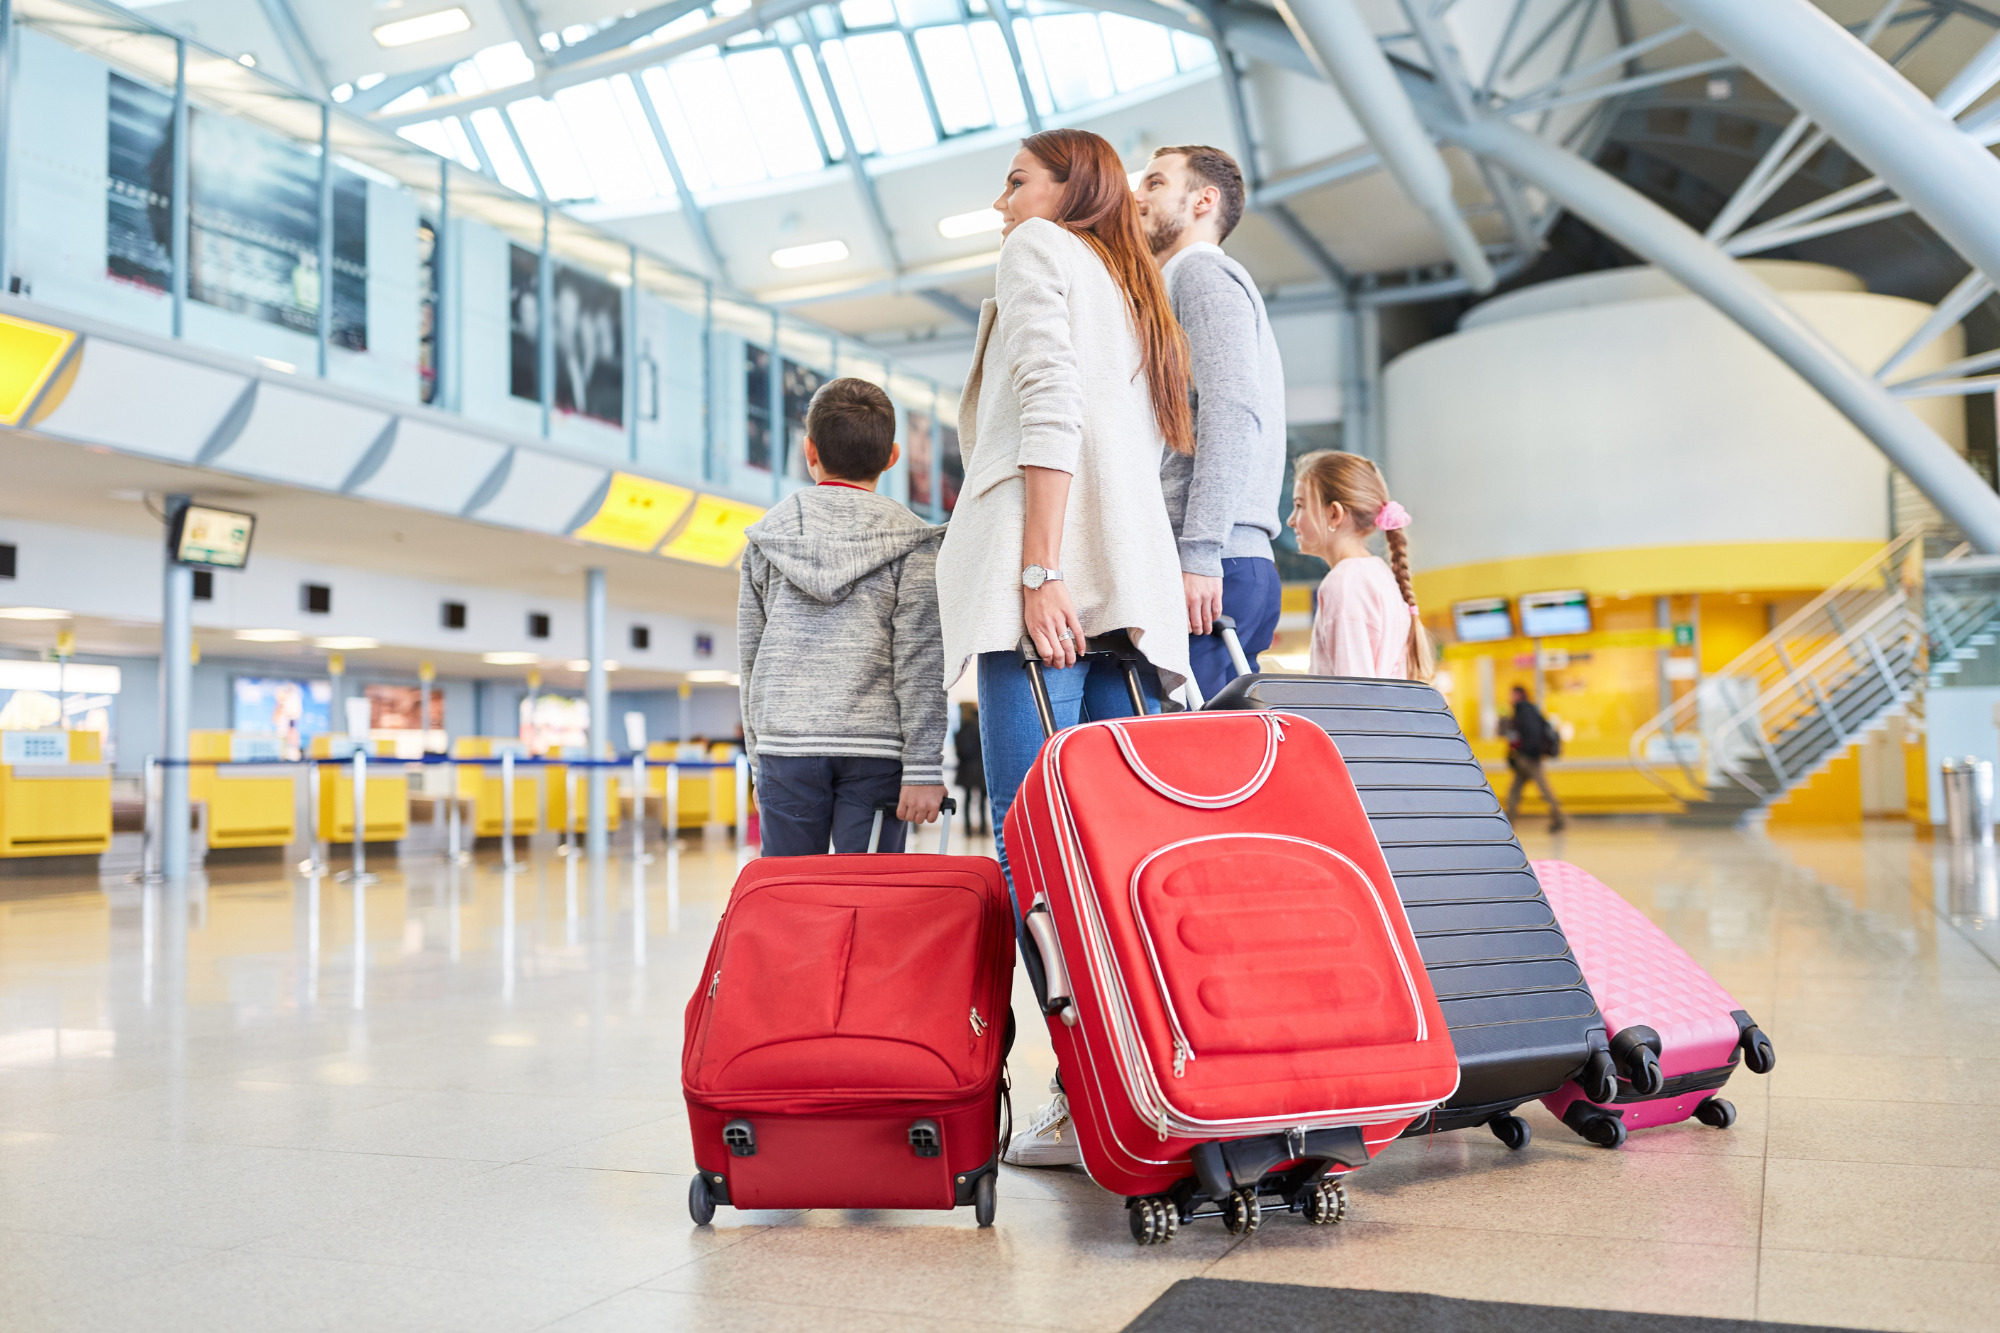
[736, 378, 946, 857]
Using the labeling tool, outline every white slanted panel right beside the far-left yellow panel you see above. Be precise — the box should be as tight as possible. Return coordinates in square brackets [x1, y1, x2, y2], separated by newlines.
[36, 338, 250, 462]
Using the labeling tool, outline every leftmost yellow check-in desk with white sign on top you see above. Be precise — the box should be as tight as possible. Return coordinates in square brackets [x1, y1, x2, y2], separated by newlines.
[0, 731, 112, 857]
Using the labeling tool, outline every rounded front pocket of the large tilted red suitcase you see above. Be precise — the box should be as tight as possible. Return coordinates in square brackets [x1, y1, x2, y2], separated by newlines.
[1132, 833, 1426, 1077]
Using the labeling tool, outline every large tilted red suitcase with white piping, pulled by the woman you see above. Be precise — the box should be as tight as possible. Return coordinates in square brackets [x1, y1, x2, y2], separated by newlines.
[1006, 644, 1458, 1245]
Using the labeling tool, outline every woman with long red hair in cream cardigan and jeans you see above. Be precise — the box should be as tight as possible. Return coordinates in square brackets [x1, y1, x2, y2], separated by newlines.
[938, 130, 1194, 1165]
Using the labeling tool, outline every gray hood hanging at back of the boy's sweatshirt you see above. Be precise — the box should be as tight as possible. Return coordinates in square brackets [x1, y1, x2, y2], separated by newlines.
[746, 486, 944, 602]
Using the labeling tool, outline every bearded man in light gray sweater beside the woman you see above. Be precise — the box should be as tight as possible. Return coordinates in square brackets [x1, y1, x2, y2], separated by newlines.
[1132, 144, 1284, 697]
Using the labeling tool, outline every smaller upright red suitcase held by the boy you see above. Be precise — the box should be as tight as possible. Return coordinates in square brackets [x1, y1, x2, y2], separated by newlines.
[680, 815, 1014, 1227]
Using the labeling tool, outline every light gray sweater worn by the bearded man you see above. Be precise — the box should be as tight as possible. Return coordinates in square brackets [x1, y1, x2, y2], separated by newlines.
[1160, 244, 1284, 578]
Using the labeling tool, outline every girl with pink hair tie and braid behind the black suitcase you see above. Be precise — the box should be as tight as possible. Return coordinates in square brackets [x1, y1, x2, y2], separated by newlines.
[1288, 448, 1436, 681]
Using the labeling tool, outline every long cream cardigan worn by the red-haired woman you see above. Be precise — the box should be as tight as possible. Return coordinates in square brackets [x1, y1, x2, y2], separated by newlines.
[938, 218, 1188, 691]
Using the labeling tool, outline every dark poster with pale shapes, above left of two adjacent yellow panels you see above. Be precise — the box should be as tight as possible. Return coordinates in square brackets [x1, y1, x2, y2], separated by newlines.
[508, 246, 624, 426]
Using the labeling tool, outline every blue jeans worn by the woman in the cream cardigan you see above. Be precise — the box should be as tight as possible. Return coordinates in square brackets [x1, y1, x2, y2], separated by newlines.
[980, 652, 1160, 913]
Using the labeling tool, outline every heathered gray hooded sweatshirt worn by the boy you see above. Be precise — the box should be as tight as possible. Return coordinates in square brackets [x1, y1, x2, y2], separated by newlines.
[736, 486, 946, 787]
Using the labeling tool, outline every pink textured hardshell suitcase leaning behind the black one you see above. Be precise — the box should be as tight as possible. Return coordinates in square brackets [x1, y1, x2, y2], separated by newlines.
[1530, 861, 1778, 1147]
